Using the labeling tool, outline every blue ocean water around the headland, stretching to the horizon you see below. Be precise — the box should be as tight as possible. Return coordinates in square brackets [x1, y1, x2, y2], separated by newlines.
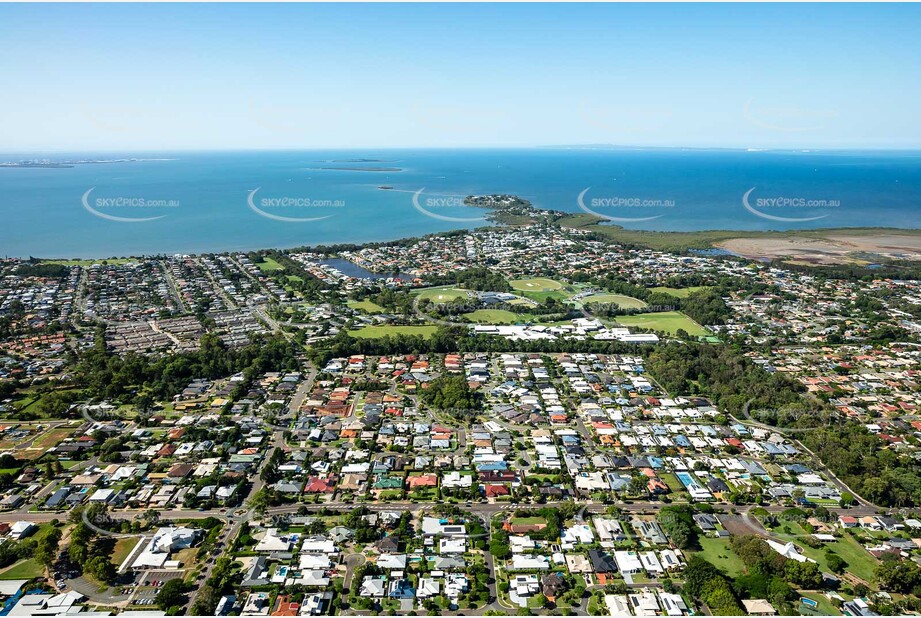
[0, 148, 921, 258]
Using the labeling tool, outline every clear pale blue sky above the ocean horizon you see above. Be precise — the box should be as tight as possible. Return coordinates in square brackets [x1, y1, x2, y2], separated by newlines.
[0, 4, 921, 151]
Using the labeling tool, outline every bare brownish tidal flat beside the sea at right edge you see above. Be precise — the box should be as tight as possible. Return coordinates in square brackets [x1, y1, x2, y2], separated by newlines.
[715, 233, 921, 264]
